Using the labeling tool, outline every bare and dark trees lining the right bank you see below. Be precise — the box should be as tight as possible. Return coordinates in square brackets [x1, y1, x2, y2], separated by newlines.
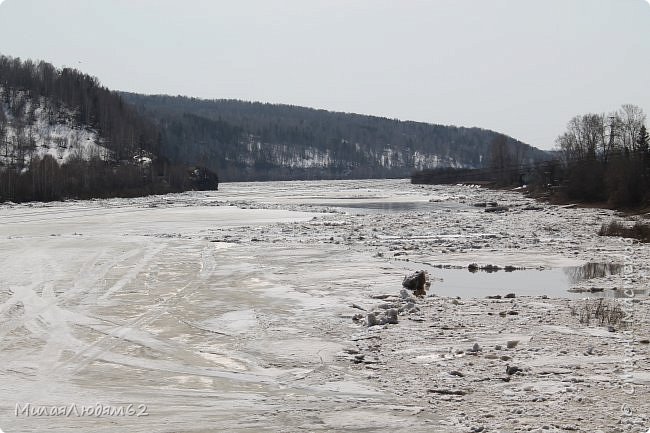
[411, 104, 650, 209]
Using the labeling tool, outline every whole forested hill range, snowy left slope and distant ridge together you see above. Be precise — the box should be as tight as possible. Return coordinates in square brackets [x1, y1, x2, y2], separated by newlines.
[0, 52, 549, 201]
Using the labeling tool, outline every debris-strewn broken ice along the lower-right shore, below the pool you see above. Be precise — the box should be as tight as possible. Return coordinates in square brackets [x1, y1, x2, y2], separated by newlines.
[341, 290, 650, 433]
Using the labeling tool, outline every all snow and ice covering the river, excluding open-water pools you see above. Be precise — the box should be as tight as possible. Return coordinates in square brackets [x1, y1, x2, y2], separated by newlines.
[0, 180, 650, 432]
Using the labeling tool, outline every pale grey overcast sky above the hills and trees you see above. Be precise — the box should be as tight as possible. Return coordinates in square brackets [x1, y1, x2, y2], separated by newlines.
[0, 0, 650, 149]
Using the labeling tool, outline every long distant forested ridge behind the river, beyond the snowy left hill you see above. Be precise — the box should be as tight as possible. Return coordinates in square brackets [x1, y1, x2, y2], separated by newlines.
[122, 93, 548, 180]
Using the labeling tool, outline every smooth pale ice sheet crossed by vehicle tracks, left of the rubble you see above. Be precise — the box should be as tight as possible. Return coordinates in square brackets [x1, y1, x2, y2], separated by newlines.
[0, 192, 440, 432]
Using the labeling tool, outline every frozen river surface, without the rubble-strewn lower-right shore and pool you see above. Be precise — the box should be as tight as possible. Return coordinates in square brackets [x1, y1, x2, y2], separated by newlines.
[0, 180, 648, 432]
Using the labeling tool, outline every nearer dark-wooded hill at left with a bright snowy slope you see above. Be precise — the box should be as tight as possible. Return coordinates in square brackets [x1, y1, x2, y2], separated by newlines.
[0, 55, 218, 202]
